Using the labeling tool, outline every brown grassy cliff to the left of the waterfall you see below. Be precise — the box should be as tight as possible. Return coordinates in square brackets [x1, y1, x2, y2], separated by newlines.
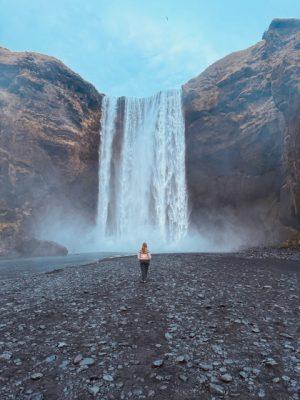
[0, 48, 102, 254]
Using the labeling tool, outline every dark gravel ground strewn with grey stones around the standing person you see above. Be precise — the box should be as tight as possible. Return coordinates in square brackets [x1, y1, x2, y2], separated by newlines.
[0, 252, 300, 400]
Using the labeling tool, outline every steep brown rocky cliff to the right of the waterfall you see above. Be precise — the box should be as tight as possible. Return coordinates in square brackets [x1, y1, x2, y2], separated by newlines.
[183, 20, 300, 241]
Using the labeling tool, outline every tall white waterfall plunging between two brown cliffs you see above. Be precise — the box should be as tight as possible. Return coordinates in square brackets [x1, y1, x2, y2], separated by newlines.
[97, 90, 188, 250]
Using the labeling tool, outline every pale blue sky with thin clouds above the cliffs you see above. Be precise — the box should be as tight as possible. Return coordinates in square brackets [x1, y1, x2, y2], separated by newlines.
[0, 0, 300, 97]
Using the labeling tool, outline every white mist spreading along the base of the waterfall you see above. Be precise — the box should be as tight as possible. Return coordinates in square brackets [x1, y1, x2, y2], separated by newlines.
[35, 202, 265, 253]
